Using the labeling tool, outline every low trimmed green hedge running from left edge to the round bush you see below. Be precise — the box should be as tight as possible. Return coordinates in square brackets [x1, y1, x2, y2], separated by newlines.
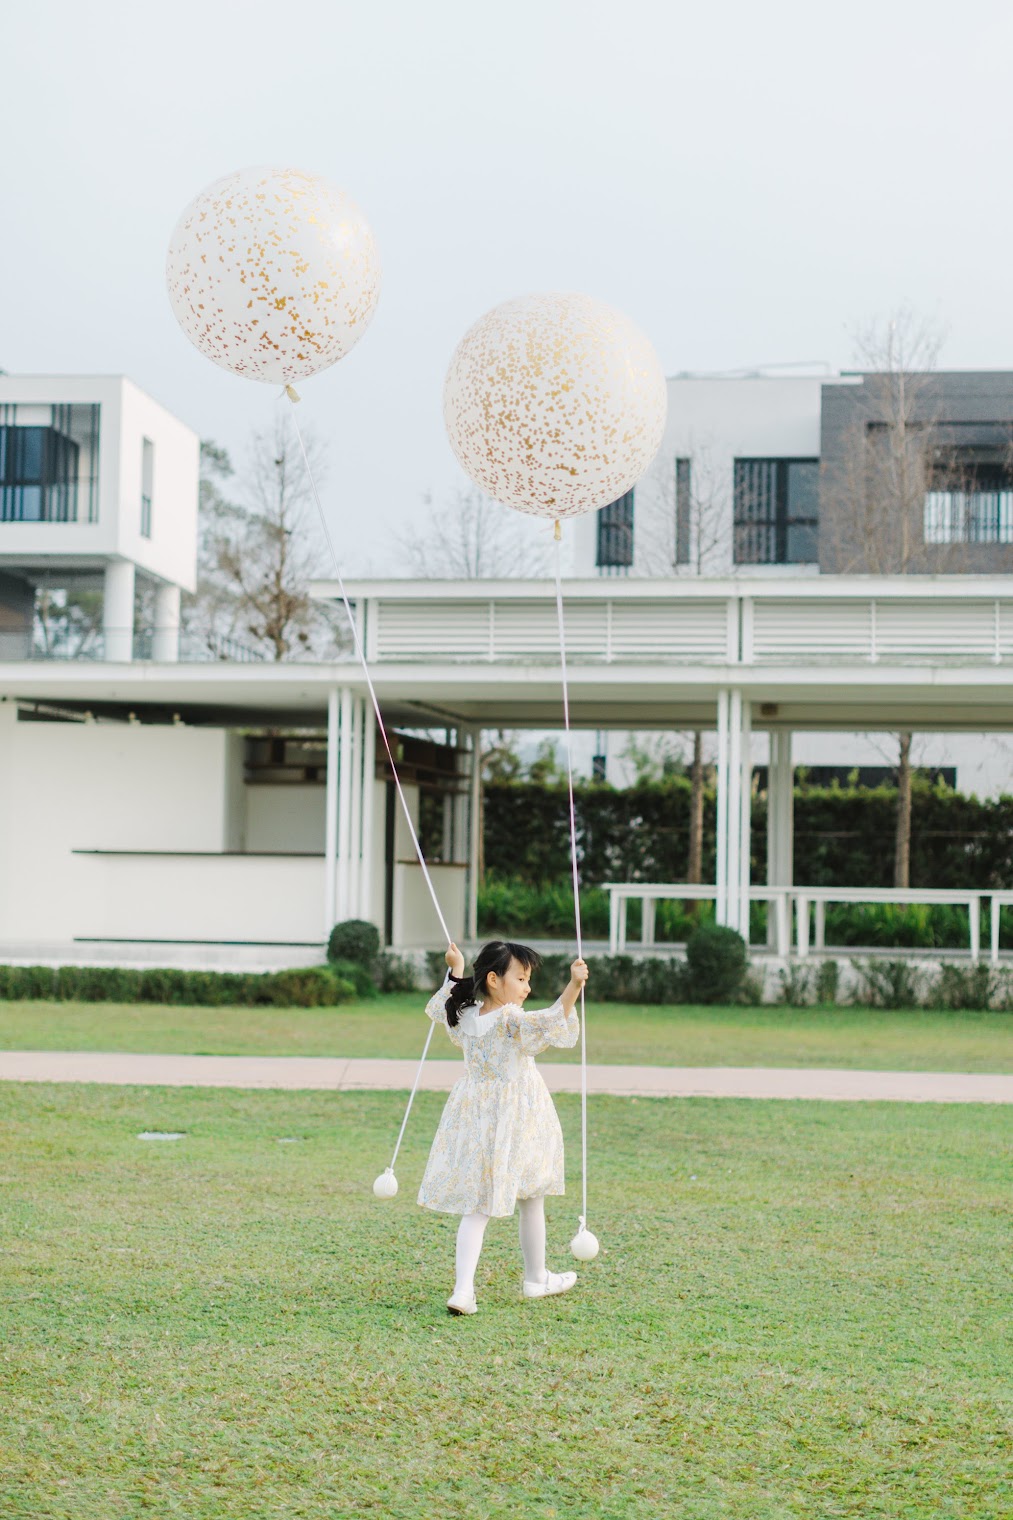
[0, 965, 351, 1008]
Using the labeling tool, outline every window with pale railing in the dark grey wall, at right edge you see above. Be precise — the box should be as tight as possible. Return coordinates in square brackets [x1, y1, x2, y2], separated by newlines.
[923, 448, 1013, 544]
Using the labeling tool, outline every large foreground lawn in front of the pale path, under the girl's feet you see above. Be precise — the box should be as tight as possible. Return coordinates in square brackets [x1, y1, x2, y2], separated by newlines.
[0, 1084, 1013, 1520]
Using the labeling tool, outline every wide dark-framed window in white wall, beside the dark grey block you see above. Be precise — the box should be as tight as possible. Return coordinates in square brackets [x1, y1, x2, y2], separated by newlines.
[735, 459, 820, 565]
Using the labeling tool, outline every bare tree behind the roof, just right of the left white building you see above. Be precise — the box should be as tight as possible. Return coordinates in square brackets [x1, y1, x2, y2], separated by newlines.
[184, 416, 347, 660]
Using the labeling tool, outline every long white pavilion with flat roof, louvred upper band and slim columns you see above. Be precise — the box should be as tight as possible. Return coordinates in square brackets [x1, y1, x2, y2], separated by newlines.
[0, 573, 1013, 938]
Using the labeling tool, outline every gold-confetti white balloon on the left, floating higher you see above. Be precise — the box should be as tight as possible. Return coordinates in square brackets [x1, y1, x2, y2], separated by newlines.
[166, 169, 380, 385]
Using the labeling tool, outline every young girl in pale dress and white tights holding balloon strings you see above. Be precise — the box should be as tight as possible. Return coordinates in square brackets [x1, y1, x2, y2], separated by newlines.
[418, 939, 587, 1315]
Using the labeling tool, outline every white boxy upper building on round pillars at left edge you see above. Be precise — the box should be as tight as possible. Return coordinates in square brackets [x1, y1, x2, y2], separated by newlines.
[0, 374, 199, 661]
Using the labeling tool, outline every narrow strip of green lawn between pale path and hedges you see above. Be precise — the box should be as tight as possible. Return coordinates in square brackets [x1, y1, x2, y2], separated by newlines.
[0, 994, 1013, 1072]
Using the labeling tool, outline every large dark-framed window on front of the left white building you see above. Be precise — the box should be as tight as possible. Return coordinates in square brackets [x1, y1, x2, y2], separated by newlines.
[0, 404, 99, 523]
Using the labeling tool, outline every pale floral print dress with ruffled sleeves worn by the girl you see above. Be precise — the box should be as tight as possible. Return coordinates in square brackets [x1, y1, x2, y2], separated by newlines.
[418, 980, 580, 1218]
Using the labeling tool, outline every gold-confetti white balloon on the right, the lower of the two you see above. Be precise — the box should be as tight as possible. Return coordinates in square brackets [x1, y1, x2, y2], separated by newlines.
[443, 292, 668, 518]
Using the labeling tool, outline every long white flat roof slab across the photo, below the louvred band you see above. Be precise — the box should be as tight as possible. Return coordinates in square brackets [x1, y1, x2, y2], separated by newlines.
[0, 661, 1013, 733]
